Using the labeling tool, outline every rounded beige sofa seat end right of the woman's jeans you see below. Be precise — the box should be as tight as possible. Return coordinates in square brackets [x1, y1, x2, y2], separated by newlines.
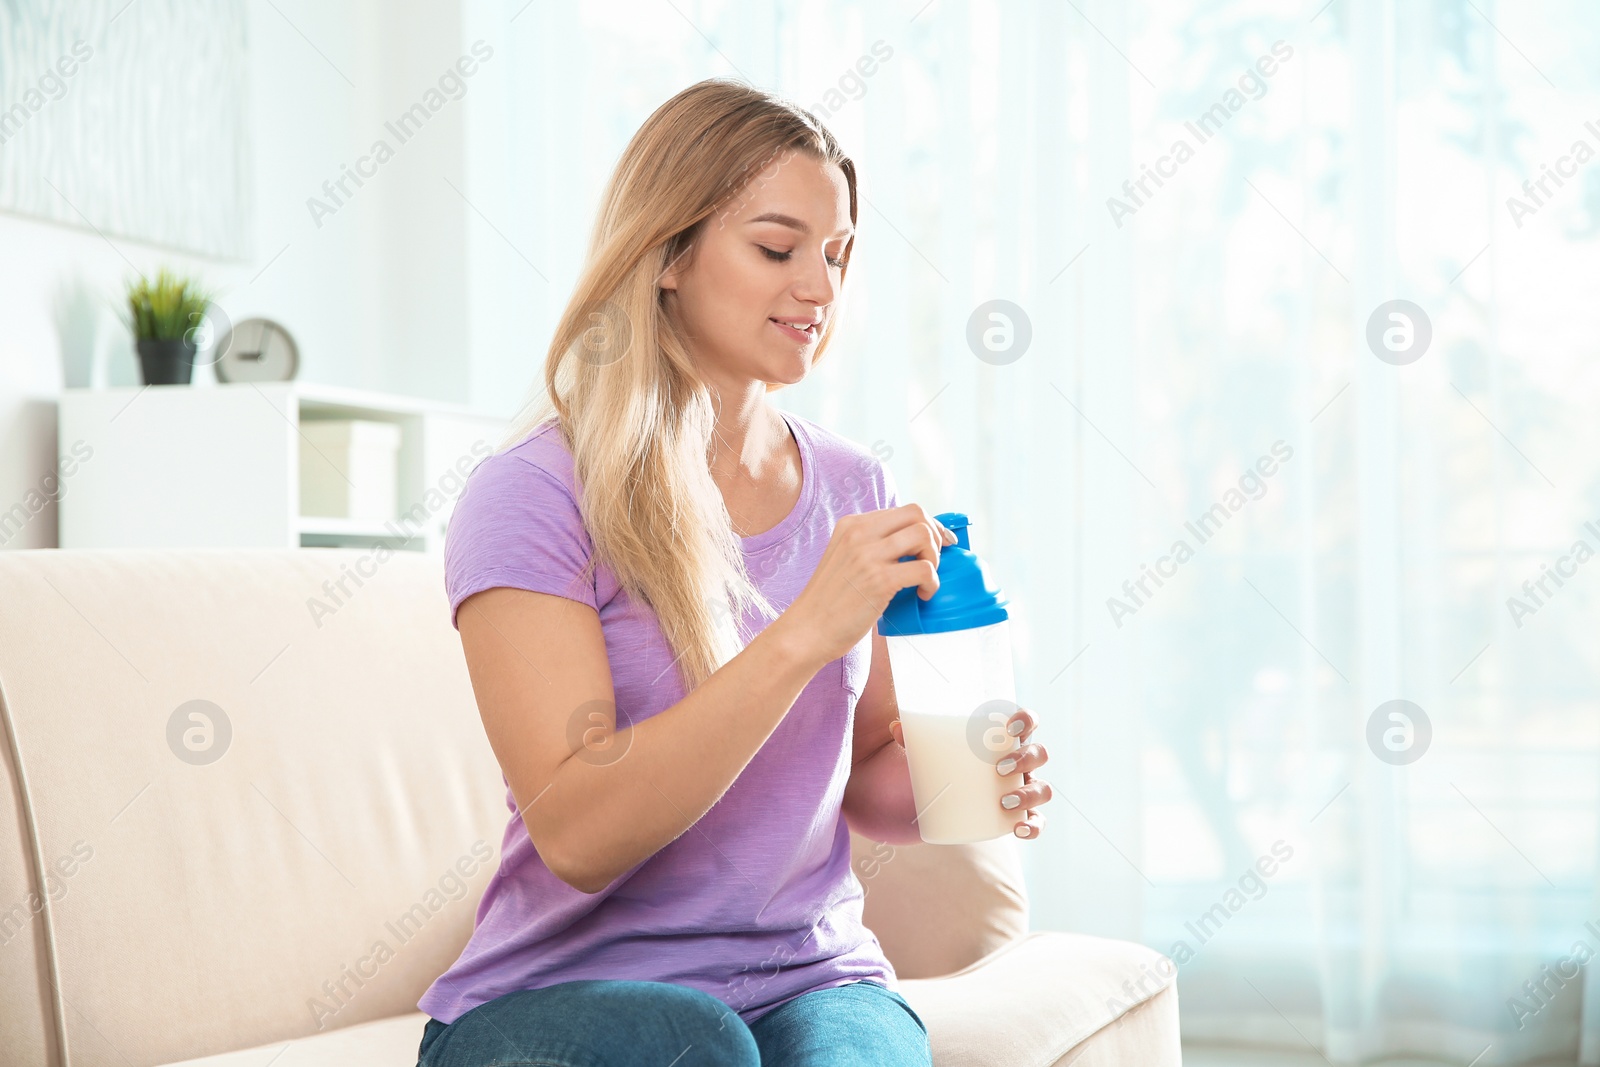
[899, 931, 1182, 1067]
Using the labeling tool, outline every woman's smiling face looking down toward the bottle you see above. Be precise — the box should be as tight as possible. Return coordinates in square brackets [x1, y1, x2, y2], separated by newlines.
[661, 149, 853, 386]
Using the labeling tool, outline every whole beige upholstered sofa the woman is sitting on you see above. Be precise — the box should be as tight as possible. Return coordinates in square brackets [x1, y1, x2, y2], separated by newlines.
[0, 549, 1179, 1067]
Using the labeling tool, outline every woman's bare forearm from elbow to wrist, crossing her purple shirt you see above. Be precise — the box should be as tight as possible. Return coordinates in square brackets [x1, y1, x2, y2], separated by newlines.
[539, 619, 821, 893]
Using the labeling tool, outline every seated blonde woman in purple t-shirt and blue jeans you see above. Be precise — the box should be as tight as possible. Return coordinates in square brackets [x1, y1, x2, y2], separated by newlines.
[419, 80, 1050, 1067]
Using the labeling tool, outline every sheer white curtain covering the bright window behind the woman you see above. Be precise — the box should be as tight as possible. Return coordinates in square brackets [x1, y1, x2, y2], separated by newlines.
[480, 0, 1600, 1065]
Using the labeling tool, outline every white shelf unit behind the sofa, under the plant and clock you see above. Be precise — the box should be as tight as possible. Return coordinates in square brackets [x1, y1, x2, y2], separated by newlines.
[58, 382, 506, 552]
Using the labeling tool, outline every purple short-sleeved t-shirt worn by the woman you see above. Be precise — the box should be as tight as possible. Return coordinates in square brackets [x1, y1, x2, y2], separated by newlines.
[418, 413, 898, 1022]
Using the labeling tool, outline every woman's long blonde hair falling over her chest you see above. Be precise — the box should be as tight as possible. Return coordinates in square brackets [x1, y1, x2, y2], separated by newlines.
[496, 78, 856, 691]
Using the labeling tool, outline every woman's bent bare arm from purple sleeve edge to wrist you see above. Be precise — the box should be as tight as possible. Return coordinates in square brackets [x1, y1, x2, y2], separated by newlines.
[458, 587, 827, 893]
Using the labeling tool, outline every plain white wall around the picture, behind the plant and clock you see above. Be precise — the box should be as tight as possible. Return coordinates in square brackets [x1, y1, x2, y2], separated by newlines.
[0, 0, 492, 549]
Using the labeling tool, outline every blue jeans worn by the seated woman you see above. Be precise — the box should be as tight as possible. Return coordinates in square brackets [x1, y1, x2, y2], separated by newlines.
[416, 979, 933, 1067]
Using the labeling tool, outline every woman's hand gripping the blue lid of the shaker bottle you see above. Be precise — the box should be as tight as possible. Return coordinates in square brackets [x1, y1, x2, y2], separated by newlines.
[773, 504, 955, 665]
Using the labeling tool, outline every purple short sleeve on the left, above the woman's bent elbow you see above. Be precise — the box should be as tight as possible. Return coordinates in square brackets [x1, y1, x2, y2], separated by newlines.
[445, 453, 598, 630]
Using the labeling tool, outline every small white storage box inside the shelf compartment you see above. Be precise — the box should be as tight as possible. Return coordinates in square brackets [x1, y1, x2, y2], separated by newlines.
[299, 419, 400, 522]
